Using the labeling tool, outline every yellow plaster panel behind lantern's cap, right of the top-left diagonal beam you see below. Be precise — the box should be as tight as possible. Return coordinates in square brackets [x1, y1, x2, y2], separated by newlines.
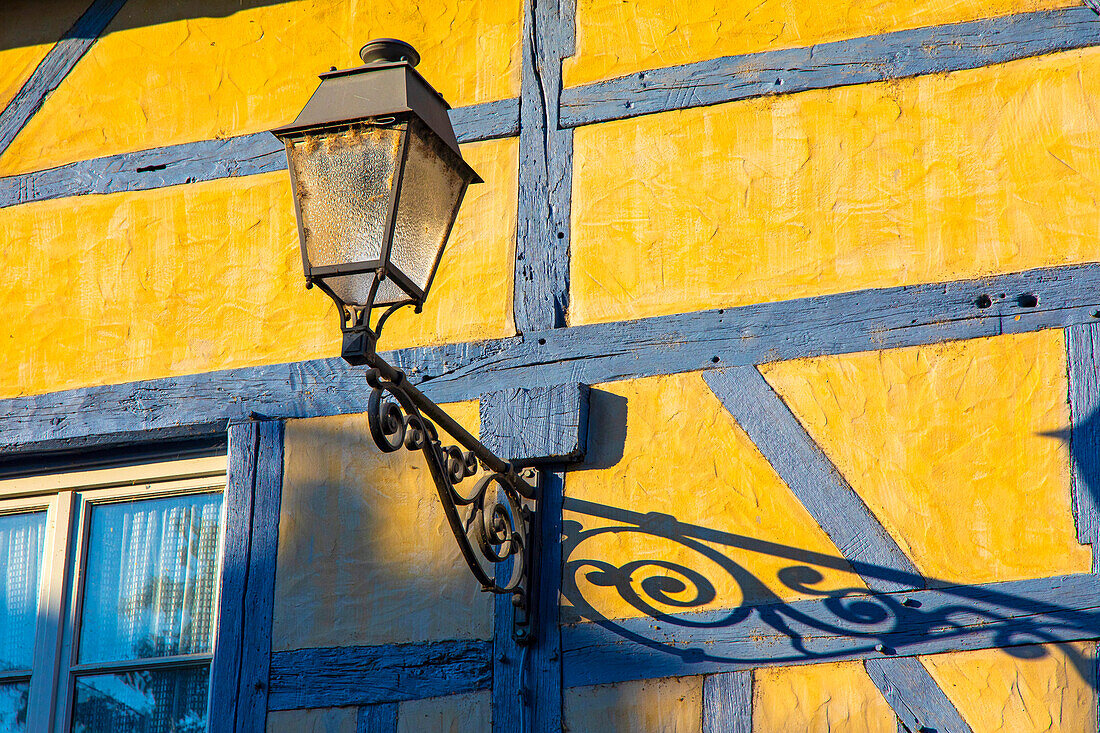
[0, 0, 523, 175]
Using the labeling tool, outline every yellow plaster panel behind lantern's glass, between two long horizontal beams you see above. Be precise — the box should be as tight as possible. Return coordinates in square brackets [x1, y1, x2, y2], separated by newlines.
[0, 140, 517, 396]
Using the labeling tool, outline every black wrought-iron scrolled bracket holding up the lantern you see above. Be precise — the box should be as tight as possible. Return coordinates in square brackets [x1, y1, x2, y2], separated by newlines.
[366, 364, 535, 638]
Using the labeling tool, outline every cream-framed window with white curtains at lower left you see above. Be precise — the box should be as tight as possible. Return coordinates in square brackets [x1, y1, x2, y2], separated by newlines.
[0, 458, 226, 733]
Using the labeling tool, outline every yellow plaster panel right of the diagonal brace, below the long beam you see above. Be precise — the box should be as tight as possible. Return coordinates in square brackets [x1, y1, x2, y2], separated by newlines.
[762, 330, 1091, 583]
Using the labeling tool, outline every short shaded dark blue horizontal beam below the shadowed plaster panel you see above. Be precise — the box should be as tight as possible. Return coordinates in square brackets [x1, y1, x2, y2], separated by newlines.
[267, 641, 493, 710]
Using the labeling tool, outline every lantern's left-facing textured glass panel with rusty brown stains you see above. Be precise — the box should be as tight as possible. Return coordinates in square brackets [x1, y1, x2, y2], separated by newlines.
[286, 123, 406, 303]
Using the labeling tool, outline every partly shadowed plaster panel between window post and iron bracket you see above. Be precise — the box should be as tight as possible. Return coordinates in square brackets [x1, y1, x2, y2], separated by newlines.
[272, 402, 493, 650]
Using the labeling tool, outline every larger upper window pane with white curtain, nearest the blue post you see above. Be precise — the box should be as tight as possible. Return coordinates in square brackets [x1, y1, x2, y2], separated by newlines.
[79, 494, 221, 660]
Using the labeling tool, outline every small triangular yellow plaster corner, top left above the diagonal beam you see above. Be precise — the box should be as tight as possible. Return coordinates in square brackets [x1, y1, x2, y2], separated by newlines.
[0, 0, 88, 109]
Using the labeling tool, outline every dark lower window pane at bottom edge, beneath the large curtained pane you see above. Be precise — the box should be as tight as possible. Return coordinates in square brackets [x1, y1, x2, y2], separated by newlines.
[73, 665, 210, 733]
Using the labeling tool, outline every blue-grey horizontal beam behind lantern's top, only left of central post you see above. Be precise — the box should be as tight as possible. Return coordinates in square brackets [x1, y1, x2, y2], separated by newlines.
[0, 99, 519, 208]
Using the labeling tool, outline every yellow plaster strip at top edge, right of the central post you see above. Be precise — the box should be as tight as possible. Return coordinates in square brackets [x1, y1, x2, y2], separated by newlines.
[564, 0, 1080, 86]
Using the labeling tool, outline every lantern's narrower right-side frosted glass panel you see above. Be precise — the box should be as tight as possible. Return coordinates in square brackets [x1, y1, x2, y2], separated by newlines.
[389, 123, 472, 294]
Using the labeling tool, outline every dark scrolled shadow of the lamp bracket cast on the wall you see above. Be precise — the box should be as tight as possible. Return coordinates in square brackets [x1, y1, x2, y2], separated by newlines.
[561, 497, 1100, 688]
